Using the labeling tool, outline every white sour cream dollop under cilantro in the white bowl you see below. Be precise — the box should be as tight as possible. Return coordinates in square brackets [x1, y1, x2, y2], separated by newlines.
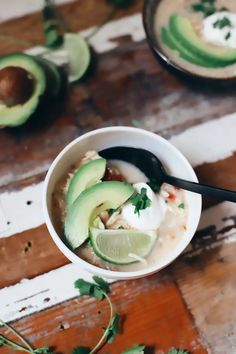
[121, 183, 167, 230]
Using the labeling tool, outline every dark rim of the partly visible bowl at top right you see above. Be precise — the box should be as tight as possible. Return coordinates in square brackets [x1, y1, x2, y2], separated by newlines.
[142, 0, 236, 83]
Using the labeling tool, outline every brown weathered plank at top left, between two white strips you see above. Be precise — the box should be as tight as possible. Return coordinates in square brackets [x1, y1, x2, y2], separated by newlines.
[0, 0, 142, 55]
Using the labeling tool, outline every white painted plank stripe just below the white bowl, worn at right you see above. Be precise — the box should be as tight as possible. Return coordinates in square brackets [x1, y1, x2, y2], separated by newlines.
[0, 202, 236, 321]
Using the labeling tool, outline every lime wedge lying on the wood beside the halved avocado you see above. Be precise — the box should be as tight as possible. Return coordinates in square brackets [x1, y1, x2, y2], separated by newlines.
[64, 33, 90, 82]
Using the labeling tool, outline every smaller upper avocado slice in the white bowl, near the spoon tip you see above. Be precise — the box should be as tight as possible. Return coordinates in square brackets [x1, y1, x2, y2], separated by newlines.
[66, 158, 106, 207]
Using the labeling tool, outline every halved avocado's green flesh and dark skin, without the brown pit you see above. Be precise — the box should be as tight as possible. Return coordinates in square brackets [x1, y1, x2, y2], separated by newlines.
[0, 53, 65, 128]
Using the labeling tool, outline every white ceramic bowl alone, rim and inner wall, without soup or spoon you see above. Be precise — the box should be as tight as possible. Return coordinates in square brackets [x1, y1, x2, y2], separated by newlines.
[43, 127, 201, 279]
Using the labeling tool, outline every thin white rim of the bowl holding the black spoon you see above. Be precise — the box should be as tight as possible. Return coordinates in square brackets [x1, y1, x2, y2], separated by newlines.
[42, 126, 202, 280]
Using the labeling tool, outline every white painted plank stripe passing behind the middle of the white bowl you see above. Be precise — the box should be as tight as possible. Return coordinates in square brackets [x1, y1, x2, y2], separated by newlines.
[0, 113, 236, 238]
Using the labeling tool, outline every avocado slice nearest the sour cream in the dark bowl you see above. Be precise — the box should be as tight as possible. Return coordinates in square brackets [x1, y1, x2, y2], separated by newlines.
[170, 15, 236, 67]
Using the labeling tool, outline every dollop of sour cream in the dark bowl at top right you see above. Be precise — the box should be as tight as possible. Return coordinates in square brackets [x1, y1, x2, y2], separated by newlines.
[202, 11, 236, 48]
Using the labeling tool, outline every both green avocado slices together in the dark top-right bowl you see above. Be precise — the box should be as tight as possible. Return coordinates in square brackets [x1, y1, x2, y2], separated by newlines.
[162, 15, 236, 68]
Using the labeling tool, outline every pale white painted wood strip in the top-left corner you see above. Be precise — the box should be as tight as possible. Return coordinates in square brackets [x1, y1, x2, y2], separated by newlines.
[0, 0, 74, 23]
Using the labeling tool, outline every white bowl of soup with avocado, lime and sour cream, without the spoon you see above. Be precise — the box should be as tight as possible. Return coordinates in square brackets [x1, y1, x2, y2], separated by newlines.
[43, 127, 201, 279]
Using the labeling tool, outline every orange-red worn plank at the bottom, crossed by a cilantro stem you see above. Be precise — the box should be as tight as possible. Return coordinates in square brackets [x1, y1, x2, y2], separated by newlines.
[2, 272, 206, 354]
